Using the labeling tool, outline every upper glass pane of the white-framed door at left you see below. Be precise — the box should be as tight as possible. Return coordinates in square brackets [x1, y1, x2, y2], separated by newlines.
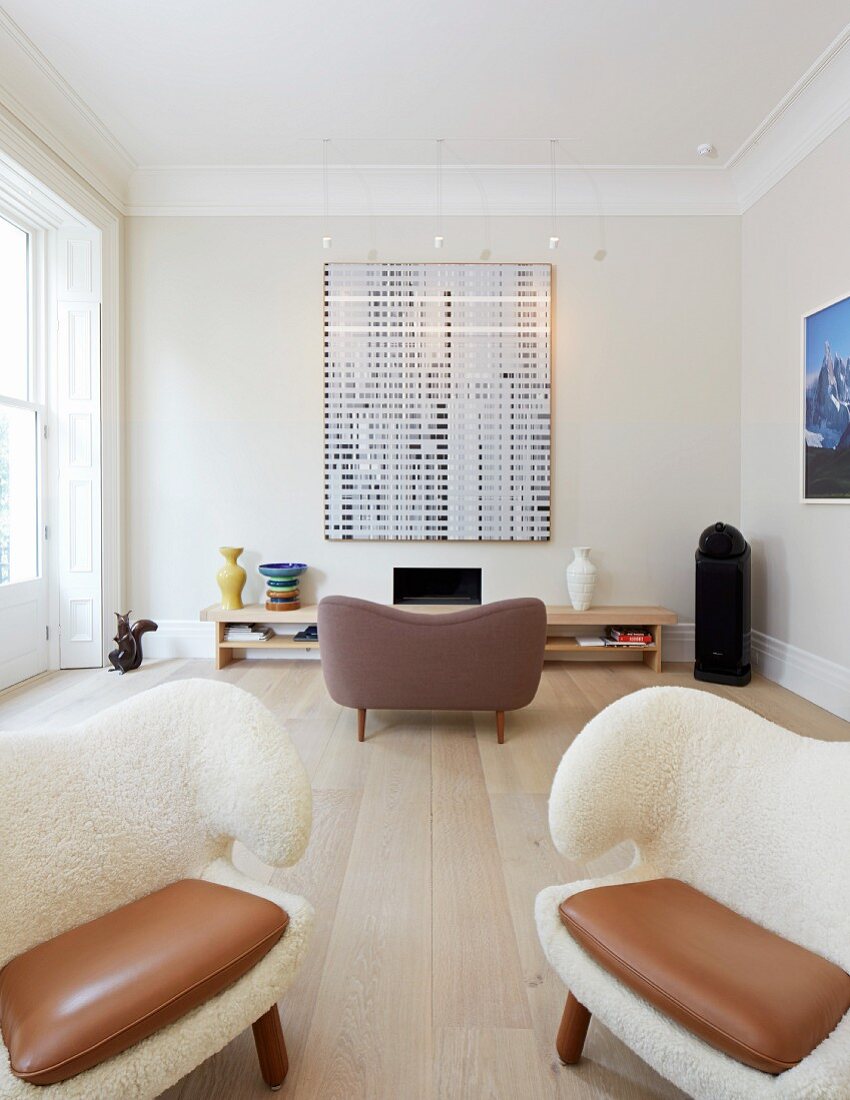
[0, 218, 30, 402]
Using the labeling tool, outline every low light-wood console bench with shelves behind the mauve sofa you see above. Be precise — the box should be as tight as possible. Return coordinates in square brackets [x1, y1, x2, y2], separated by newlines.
[200, 604, 678, 672]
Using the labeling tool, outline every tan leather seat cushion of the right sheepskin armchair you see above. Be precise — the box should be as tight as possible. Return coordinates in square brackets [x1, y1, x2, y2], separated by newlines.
[560, 879, 850, 1074]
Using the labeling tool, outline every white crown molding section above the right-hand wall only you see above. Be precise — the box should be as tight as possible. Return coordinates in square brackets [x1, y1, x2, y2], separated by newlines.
[724, 24, 850, 213]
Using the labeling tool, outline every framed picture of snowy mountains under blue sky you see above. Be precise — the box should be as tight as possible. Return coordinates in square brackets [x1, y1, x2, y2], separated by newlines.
[802, 297, 850, 504]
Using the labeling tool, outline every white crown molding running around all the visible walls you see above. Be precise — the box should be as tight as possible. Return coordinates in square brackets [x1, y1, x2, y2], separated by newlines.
[0, 8, 850, 218]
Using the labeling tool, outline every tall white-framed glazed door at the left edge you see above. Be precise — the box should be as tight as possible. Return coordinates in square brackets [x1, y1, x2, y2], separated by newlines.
[0, 217, 48, 689]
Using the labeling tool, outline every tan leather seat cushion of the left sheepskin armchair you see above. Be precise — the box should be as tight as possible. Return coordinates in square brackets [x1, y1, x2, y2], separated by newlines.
[0, 879, 289, 1085]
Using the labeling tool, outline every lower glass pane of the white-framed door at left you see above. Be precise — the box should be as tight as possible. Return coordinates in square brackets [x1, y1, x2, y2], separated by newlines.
[0, 405, 38, 584]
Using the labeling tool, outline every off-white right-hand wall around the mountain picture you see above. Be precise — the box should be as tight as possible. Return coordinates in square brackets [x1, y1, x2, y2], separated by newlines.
[741, 123, 850, 704]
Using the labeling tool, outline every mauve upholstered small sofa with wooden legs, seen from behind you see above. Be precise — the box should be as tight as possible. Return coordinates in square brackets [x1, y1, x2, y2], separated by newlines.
[319, 596, 547, 744]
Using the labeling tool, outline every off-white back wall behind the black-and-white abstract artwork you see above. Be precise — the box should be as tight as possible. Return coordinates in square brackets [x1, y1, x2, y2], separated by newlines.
[126, 217, 740, 620]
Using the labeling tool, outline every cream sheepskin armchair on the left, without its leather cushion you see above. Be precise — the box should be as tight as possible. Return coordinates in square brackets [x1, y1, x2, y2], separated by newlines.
[0, 680, 313, 1100]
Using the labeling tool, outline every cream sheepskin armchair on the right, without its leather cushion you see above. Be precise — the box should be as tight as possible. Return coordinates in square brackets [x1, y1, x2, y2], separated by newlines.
[536, 688, 850, 1100]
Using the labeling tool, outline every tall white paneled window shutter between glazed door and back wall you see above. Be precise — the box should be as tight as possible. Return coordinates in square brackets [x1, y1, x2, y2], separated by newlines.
[56, 230, 103, 669]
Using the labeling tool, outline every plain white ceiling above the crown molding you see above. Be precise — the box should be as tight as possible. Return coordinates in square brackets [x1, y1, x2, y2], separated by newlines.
[3, 0, 848, 165]
